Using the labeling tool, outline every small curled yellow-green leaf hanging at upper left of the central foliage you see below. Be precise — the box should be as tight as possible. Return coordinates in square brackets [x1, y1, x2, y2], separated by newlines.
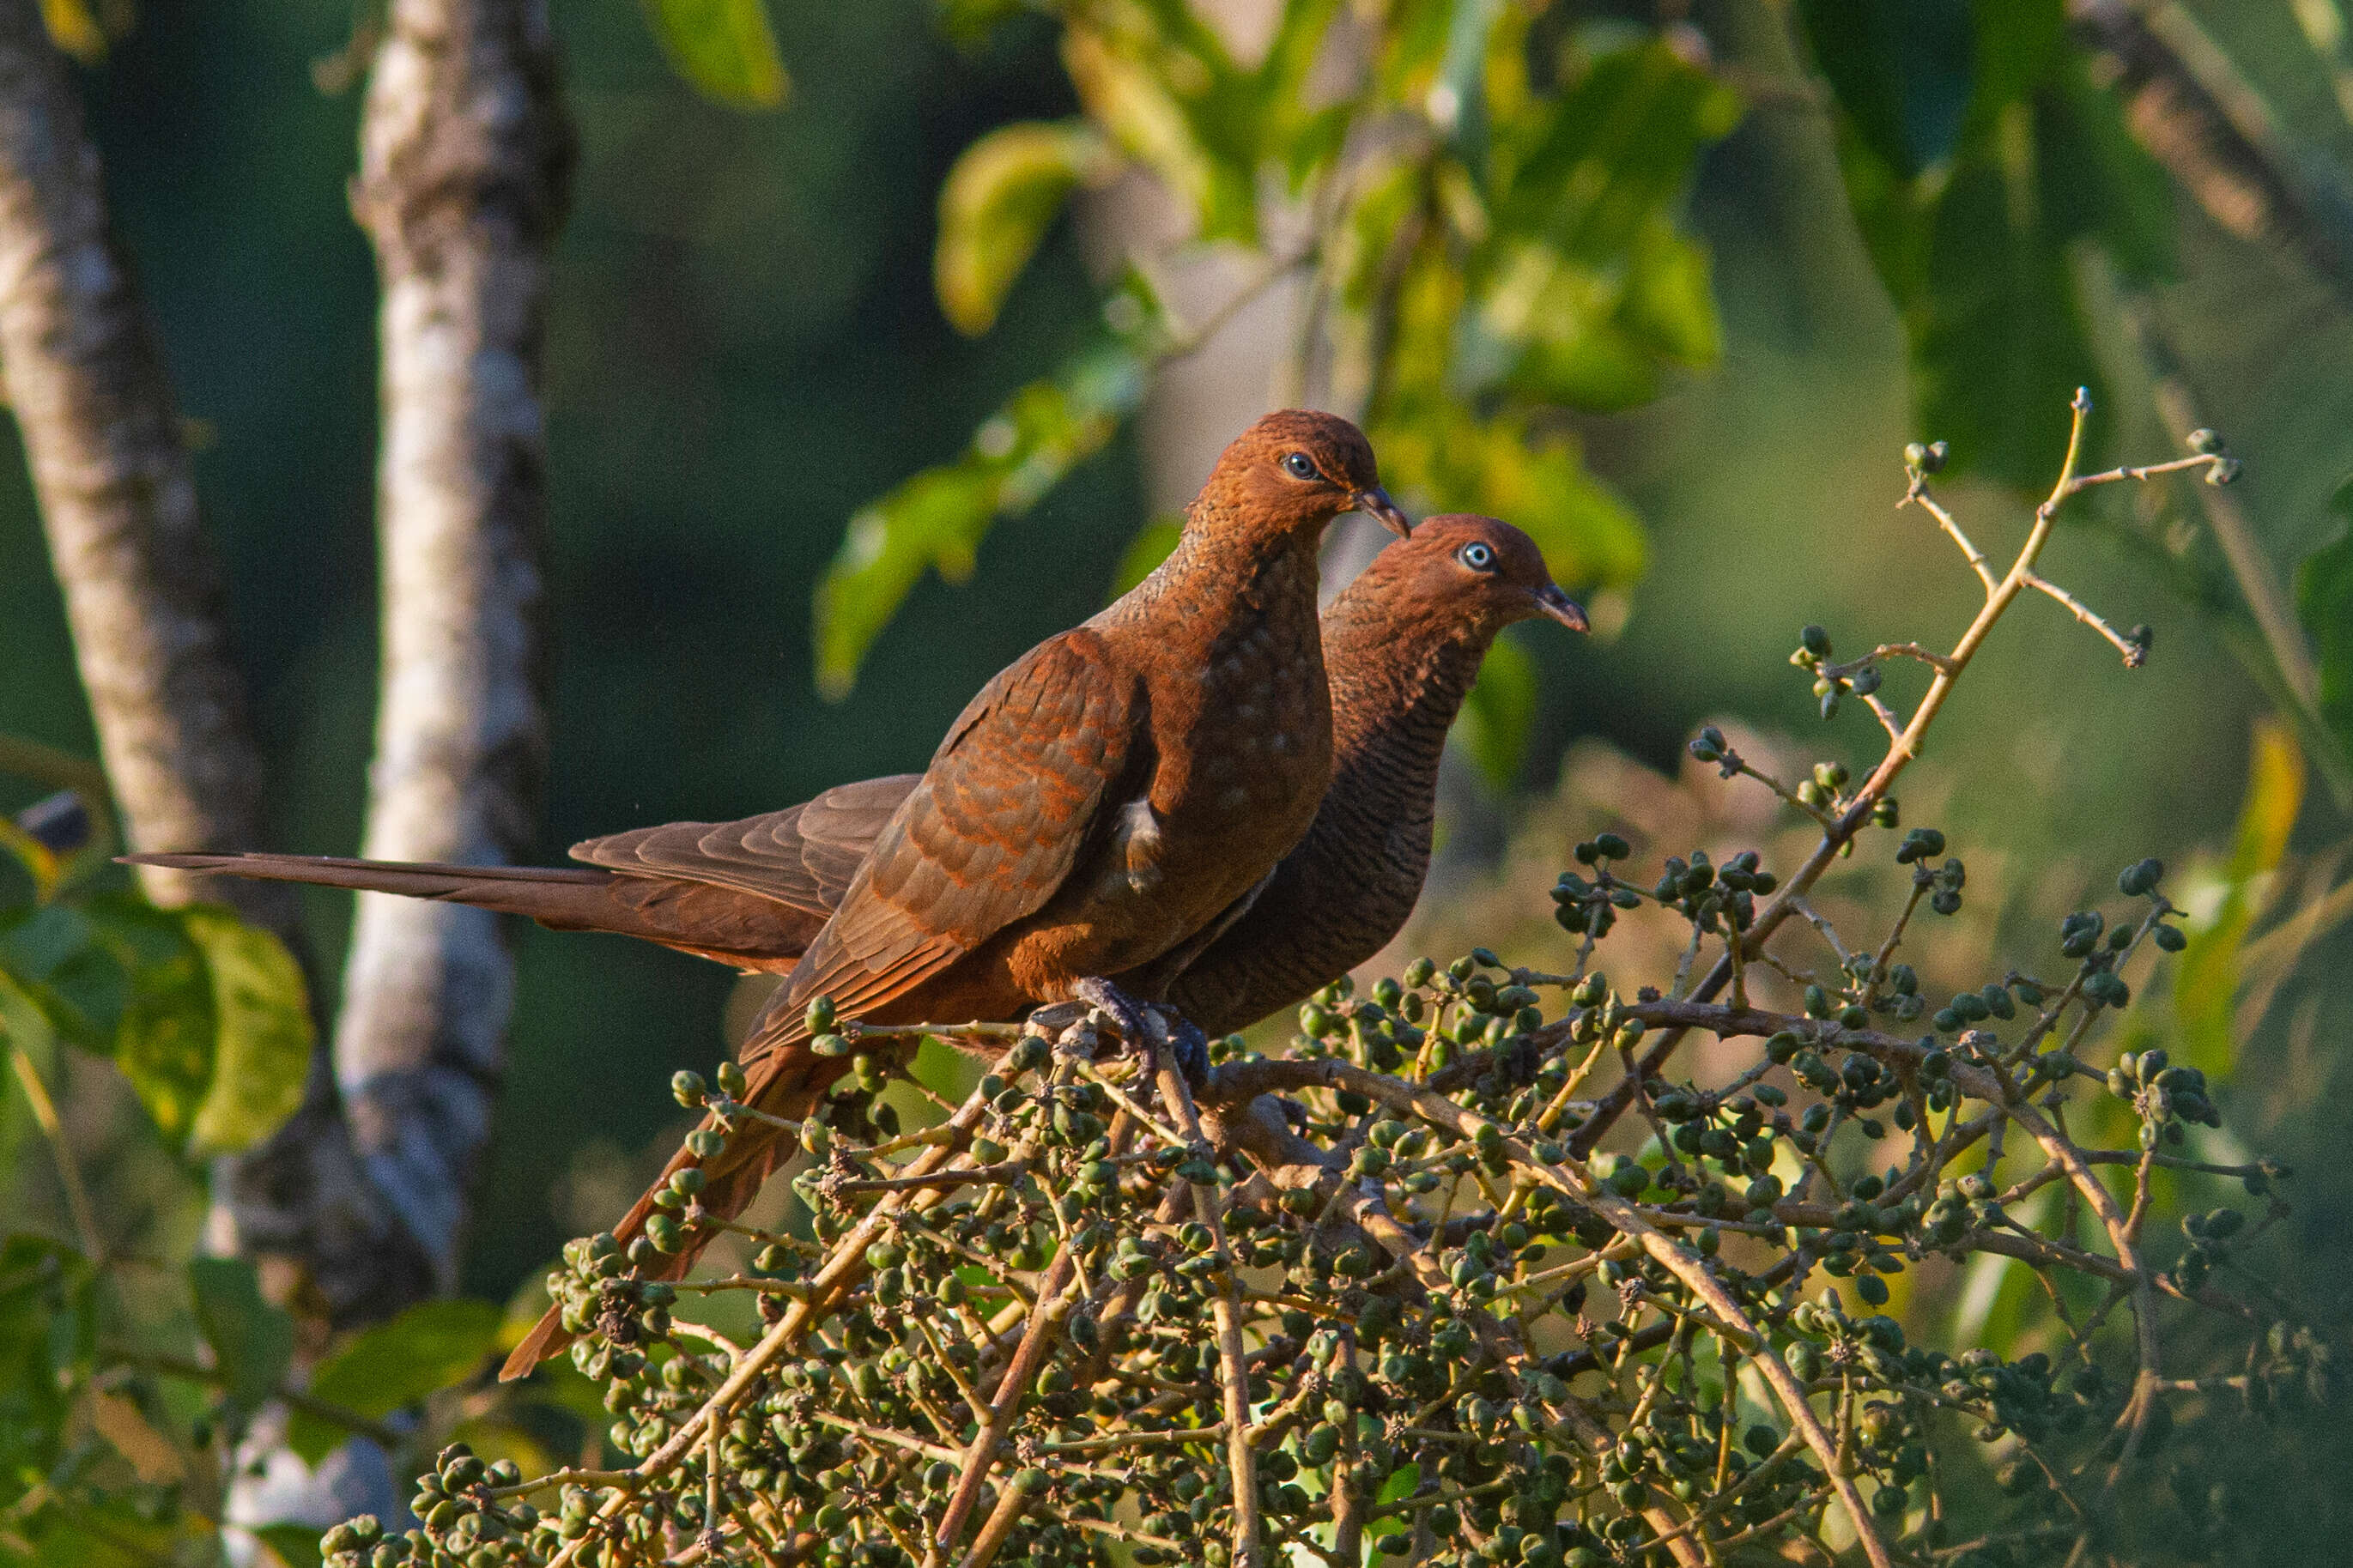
[931, 120, 1115, 336]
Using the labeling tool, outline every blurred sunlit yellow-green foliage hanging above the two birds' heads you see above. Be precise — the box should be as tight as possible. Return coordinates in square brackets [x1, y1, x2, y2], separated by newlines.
[816, 0, 1739, 700]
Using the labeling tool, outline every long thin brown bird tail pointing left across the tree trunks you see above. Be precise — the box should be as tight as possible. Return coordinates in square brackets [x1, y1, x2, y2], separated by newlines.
[123, 853, 826, 973]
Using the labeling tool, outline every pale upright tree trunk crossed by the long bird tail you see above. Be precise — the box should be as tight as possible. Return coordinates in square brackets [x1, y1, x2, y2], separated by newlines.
[334, 0, 572, 1291]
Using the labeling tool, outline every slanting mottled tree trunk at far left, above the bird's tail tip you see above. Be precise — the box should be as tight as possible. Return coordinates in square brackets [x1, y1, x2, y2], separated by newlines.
[0, 0, 296, 935]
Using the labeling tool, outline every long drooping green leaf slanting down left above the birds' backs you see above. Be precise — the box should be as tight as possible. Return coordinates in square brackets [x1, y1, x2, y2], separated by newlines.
[816, 341, 1143, 700]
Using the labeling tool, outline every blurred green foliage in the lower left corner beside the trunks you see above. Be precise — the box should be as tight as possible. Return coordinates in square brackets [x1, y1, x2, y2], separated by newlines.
[0, 797, 336, 1565]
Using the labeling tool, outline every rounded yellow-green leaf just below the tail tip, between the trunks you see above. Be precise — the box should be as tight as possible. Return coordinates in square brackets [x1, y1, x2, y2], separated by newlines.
[179, 905, 311, 1157]
